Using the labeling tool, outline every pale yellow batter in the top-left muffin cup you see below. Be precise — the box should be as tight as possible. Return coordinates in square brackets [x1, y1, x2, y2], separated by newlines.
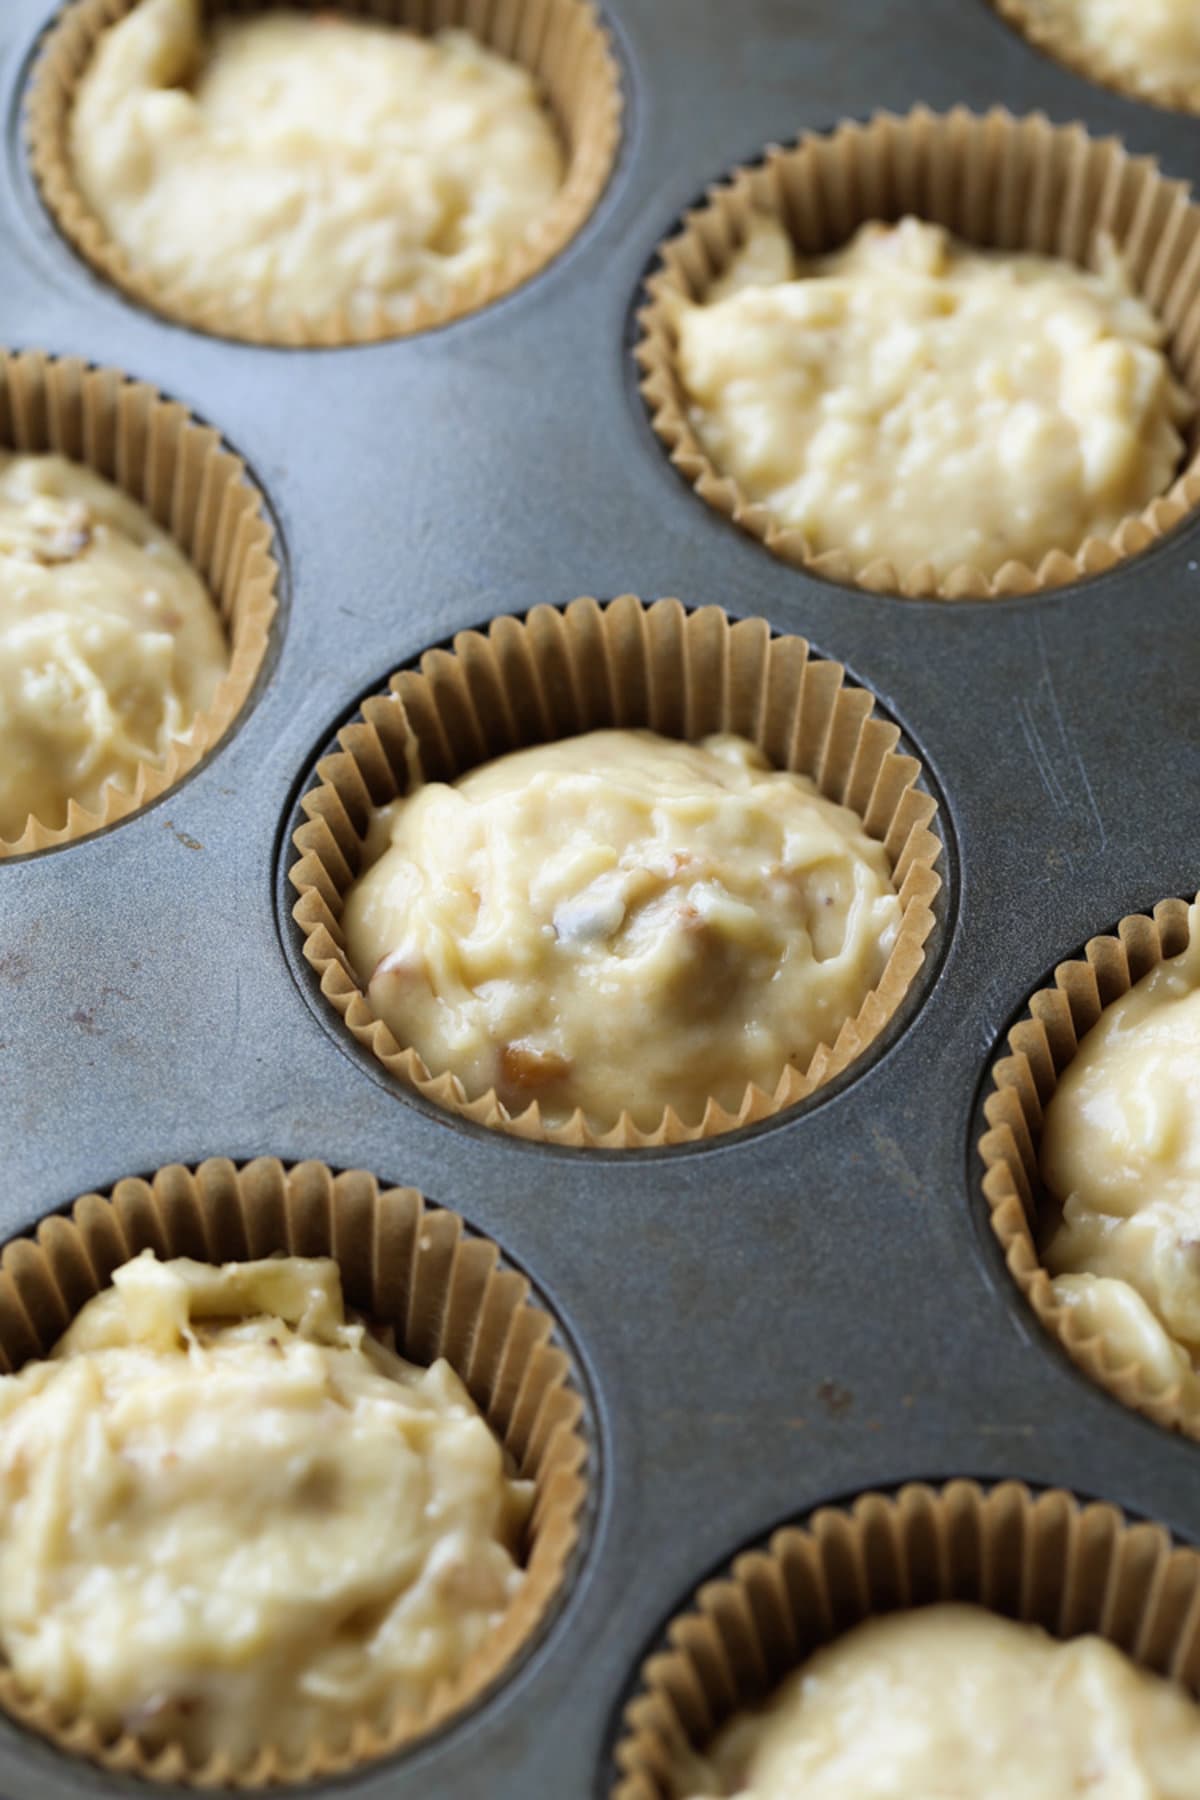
[70, 0, 563, 329]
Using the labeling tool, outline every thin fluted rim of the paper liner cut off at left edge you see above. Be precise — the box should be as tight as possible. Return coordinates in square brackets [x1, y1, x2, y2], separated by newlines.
[0, 349, 281, 862]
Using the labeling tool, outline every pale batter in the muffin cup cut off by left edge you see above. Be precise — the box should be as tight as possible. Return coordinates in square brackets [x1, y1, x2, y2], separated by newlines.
[0, 450, 228, 839]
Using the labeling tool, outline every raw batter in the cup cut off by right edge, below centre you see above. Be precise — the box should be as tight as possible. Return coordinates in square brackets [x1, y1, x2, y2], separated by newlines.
[1042, 905, 1200, 1397]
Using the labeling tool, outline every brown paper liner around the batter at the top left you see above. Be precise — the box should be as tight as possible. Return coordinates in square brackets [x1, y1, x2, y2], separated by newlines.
[25, 0, 621, 347]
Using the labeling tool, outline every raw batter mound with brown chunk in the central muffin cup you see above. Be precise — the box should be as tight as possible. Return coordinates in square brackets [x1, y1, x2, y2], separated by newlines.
[344, 731, 900, 1129]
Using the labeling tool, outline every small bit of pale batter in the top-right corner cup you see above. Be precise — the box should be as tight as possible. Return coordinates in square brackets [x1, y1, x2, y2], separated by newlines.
[1024, 0, 1200, 99]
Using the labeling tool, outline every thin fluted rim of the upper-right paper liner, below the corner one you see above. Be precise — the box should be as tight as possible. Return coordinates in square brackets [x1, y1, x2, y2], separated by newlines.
[633, 107, 1200, 601]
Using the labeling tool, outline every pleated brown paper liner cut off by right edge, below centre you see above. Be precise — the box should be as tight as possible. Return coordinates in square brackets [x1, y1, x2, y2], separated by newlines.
[979, 900, 1200, 1438]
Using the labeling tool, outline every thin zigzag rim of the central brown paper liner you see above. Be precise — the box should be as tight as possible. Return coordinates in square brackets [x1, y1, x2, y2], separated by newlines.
[288, 594, 945, 1150]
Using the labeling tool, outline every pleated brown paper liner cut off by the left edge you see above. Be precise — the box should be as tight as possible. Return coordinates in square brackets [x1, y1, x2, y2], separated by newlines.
[0, 351, 279, 859]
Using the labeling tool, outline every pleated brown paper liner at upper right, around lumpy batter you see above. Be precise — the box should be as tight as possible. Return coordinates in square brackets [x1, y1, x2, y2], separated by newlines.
[635, 108, 1200, 599]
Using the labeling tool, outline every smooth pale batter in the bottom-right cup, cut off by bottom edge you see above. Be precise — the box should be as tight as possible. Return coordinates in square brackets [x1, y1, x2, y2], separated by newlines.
[694, 1606, 1200, 1800]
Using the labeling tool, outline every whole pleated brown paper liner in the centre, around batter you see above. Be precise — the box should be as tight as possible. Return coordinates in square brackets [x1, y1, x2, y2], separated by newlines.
[290, 594, 943, 1148]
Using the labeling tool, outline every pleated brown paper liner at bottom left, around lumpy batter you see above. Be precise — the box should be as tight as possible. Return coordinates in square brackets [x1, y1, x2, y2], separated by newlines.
[0, 1157, 588, 1787]
